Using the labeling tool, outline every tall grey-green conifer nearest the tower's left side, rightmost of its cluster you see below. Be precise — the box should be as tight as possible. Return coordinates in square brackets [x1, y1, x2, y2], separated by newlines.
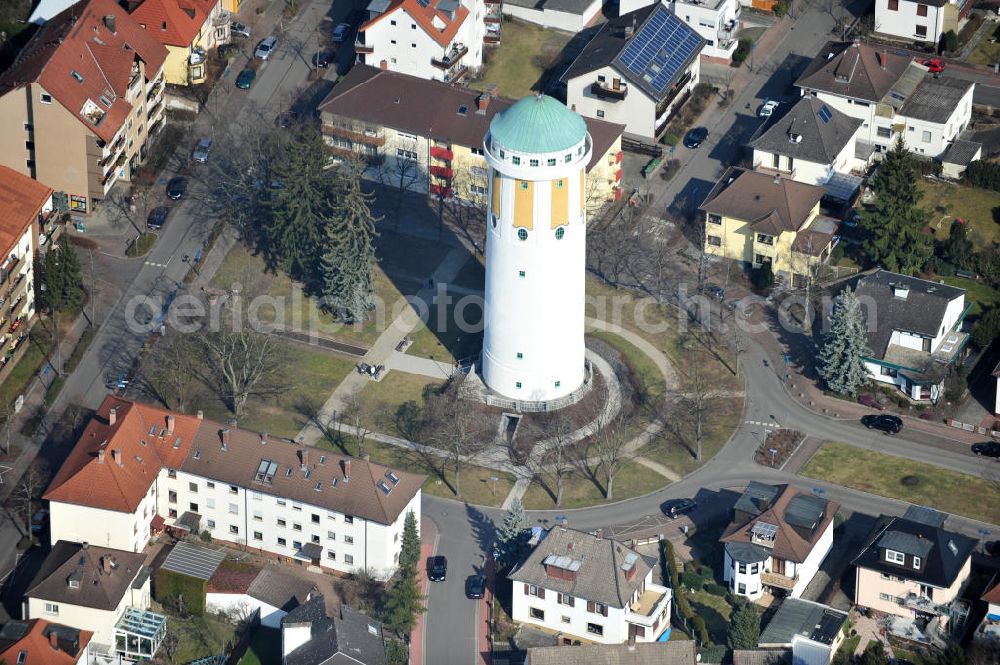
[319, 161, 378, 321]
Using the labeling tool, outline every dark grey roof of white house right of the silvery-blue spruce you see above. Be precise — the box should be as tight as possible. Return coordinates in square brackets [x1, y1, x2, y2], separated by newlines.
[856, 270, 965, 358]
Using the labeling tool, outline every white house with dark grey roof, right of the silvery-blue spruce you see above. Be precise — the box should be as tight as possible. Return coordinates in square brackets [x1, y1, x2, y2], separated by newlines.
[855, 270, 972, 401]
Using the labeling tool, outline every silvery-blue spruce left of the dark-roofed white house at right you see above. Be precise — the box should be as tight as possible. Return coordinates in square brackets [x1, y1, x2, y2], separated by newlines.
[818, 287, 871, 397]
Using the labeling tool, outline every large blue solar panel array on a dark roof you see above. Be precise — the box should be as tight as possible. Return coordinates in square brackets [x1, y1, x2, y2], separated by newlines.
[618, 6, 701, 94]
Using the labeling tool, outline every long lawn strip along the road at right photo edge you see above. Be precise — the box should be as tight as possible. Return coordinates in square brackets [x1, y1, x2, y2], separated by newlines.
[801, 441, 1000, 522]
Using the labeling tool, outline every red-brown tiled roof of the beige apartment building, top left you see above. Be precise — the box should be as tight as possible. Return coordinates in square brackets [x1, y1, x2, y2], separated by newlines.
[0, 0, 167, 141]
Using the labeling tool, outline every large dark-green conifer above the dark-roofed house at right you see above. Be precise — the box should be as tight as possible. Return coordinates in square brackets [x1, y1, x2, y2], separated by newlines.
[861, 137, 932, 275]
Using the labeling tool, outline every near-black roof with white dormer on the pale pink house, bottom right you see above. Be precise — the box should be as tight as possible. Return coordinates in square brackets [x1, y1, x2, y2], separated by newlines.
[853, 515, 976, 588]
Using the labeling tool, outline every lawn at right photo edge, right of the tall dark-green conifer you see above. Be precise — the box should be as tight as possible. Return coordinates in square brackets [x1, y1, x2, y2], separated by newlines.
[917, 178, 1000, 246]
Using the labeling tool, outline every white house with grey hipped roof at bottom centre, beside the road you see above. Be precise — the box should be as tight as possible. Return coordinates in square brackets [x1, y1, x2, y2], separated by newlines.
[508, 526, 673, 644]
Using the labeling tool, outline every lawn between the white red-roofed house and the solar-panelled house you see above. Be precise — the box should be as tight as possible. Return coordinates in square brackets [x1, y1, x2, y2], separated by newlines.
[470, 18, 573, 99]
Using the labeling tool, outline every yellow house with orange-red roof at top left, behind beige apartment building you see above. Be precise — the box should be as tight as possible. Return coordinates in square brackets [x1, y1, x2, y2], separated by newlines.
[131, 0, 232, 85]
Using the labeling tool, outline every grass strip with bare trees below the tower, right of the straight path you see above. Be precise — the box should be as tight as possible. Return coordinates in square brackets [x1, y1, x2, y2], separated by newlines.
[523, 462, 670, 510]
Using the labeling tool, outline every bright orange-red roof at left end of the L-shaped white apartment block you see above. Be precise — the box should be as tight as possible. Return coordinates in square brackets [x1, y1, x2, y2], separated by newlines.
[44, 395, 200, 513]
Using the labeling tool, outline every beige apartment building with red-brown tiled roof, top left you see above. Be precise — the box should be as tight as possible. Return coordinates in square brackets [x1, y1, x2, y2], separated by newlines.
[0, 0, 167, 213]
